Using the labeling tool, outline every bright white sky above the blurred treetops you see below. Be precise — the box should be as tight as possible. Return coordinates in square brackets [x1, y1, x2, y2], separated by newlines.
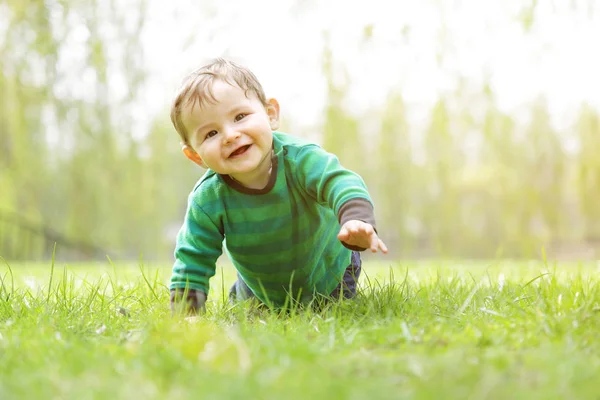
[51, 0, 600, 142]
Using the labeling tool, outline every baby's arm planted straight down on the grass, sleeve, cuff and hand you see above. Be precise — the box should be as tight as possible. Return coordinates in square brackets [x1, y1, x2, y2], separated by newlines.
[170, 194, 224, 314]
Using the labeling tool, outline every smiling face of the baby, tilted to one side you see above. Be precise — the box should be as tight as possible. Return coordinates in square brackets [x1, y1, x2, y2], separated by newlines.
[181, 80, 278, 188]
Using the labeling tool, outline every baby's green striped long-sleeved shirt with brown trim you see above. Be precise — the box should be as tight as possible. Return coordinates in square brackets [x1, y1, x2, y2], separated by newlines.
[170, 132, 375, 305]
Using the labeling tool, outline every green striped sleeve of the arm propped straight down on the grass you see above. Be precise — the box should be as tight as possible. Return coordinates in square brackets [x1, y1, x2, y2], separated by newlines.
[170, 193, 224, 294]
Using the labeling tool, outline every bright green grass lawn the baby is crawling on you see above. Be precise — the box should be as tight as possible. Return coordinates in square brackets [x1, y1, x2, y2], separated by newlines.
[0, 261, 600, 400]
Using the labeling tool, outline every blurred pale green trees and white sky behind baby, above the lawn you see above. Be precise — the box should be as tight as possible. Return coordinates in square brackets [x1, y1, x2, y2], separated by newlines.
[0, 0, 600, 262]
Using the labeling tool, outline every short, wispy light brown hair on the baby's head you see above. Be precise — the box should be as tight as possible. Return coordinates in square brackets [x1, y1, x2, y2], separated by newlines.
[171, 58, 268, 143]
